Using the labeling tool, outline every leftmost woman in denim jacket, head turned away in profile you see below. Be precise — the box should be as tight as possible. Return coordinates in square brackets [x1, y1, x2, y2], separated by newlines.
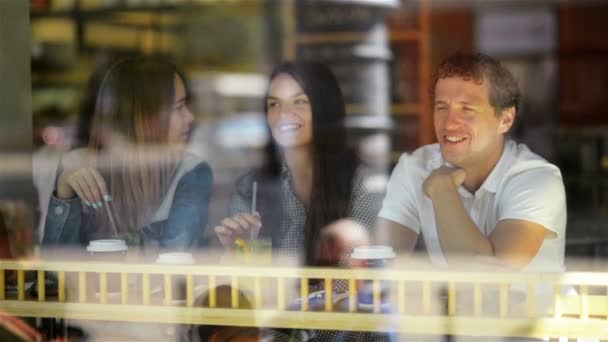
[43, 57, 212, 249]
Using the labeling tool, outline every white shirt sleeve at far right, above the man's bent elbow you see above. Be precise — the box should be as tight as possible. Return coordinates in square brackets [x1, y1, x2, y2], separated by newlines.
[498, 168, 566, 238]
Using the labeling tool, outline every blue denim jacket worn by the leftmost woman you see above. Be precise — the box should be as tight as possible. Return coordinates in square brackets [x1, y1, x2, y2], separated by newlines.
[42, 156, 213, 250]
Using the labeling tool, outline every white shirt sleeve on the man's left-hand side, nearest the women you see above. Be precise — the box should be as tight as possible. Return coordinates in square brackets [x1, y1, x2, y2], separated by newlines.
[378, 153, 420, 234]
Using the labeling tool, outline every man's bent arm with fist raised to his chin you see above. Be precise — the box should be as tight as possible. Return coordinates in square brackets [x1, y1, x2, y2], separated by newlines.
[424, 168, 548, 269]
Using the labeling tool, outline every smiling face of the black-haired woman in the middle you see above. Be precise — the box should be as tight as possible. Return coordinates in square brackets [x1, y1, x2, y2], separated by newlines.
[266, 74, 312, 148]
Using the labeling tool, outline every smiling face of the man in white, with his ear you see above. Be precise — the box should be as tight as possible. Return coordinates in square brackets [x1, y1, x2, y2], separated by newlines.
[433, 77, 515, 169]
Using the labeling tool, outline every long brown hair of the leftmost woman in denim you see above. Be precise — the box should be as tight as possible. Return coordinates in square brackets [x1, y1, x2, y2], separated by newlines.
[89, 58, 185, 243]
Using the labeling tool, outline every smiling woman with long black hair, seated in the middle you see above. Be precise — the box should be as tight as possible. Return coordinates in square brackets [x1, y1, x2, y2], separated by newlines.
[215, 62, 382, 265]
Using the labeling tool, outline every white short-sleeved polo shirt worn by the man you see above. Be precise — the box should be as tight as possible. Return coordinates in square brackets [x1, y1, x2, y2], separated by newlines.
[379, 140, 566, 272]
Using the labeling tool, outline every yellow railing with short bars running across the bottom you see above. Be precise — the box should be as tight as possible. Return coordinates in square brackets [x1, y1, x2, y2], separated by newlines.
[0, 260, 608, 338]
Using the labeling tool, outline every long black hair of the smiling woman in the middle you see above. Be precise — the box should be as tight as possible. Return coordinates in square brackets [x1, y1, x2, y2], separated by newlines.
[239, 62, 358, 265]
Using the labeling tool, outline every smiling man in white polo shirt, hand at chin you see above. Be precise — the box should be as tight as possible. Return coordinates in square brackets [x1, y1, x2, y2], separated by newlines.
[376, 53, 566, 271]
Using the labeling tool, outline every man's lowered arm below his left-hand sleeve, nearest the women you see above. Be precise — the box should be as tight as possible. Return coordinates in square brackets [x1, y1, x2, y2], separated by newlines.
[373, 217, 418, 254]
